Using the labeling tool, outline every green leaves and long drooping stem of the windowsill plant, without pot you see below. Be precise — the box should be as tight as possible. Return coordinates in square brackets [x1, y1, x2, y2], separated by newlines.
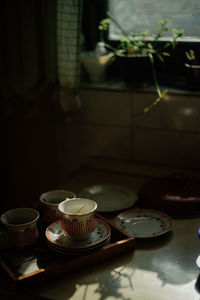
[99, 12, 184, 116]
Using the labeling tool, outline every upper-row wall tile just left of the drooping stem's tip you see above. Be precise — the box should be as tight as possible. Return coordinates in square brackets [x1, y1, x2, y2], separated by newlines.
[80, 90, 131, 127]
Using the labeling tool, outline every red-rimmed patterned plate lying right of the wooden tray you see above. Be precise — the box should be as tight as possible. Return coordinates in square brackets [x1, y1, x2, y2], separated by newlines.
[114, 209, 173, 238]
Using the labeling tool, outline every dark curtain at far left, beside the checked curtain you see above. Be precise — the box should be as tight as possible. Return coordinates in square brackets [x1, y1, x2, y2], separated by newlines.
[0, 0, 57, 98]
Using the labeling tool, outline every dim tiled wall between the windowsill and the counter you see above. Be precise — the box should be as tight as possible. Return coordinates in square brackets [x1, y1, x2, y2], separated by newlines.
[74, 88, 200, 168]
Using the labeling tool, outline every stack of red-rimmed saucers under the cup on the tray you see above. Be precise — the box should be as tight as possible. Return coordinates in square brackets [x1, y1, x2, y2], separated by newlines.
[45, 219, 111, 255]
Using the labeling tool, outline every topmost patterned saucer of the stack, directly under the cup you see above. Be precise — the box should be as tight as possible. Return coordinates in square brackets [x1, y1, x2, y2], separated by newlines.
[45, 219, 111, 250]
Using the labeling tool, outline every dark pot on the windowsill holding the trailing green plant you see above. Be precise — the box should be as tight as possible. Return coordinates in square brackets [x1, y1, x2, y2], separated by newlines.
[116, 51, 153, 87]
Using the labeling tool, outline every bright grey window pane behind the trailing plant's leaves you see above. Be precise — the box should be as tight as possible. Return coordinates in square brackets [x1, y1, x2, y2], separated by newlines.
[108, 0, 200, 42]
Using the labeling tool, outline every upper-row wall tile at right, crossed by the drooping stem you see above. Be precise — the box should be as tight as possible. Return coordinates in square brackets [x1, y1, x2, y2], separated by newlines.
[132, 93, 200, 132]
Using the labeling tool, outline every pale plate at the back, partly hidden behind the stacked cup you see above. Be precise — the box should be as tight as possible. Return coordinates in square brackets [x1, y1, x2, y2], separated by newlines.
[79, 185, 138, 212]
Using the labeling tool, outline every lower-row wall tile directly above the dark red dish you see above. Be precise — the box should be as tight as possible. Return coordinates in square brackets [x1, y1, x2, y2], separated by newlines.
[132, 129, 200, 168]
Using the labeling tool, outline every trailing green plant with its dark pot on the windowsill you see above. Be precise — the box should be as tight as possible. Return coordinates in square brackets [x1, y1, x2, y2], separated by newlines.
[99, 13, 184, 112]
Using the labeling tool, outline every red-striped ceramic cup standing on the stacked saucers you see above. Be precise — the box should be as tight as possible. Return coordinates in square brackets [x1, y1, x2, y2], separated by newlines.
[58, 198, 97, 240]
